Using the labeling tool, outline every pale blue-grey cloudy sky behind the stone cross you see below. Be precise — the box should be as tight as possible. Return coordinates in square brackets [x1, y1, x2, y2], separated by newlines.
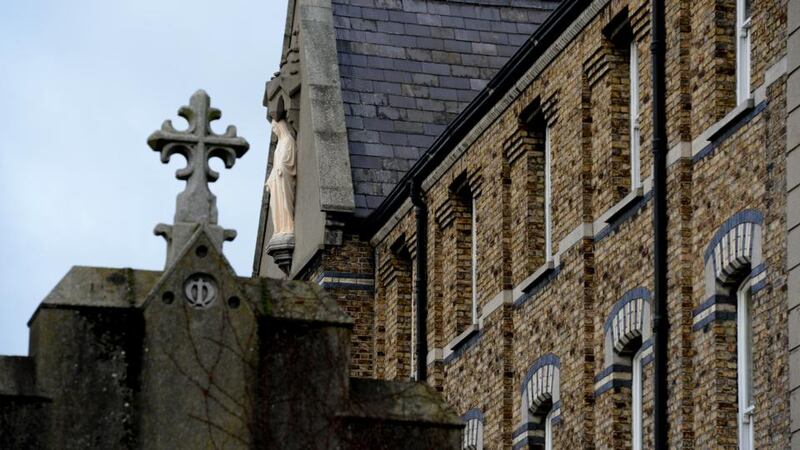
[0, 0, 286, 354]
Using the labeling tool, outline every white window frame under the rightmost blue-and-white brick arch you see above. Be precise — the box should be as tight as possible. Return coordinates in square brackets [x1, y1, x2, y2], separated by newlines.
[736, 279, 755, 450]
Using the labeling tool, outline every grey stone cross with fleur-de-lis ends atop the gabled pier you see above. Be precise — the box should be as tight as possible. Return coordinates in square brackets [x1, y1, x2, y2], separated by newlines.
[147, 90, 250, 266]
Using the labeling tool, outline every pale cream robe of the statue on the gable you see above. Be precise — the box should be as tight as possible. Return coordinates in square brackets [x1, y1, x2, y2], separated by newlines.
[267, 120, 297, 239]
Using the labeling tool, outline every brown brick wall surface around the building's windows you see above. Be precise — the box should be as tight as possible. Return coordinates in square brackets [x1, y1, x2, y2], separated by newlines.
[364, 0, 789, 449]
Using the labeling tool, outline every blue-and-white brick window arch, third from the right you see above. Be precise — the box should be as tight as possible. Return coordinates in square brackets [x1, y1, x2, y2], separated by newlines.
[513, 353, 561, 449]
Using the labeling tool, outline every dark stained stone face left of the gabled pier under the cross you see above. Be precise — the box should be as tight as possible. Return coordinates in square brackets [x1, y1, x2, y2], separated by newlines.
[30, 306, 143, 449]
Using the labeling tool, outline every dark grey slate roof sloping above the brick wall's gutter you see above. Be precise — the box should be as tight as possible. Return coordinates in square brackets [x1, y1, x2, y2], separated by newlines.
[332, 0, 559, 216]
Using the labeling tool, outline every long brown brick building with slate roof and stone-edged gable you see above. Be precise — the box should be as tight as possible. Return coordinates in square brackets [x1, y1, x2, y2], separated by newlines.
[255, 0, 800, 449]
